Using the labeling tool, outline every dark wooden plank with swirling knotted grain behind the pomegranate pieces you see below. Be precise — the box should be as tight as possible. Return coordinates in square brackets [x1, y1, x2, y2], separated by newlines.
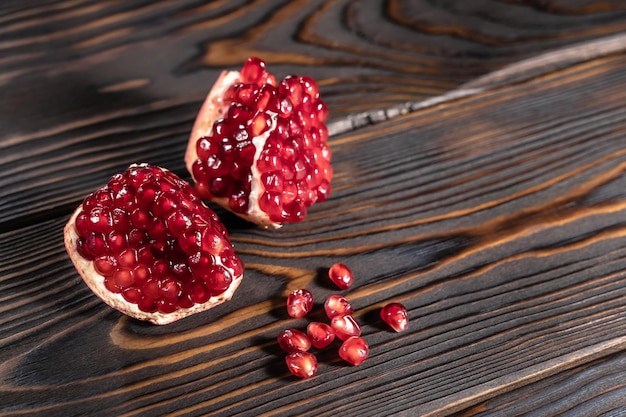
[0, 0, 626, 230]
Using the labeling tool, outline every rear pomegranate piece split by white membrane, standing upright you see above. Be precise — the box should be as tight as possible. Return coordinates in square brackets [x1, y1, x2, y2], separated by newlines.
[185, 57, 332, 227]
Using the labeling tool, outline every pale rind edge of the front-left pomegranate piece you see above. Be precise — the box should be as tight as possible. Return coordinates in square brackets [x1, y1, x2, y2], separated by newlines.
[63, 164, 243, 325]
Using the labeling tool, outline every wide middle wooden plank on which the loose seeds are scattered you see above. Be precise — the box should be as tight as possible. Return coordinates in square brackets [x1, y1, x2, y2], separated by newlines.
[0, 48, 626, 416]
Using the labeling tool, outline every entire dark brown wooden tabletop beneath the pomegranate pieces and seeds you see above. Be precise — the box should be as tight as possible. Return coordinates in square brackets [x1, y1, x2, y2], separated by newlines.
[0, 0, 626, 416]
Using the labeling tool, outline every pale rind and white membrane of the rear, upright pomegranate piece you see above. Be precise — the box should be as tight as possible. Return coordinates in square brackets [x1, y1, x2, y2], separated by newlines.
[185, 71, 282, 229]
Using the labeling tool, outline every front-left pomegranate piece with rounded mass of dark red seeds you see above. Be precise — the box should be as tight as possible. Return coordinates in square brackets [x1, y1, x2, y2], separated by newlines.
[65, 164, 243, 324]
